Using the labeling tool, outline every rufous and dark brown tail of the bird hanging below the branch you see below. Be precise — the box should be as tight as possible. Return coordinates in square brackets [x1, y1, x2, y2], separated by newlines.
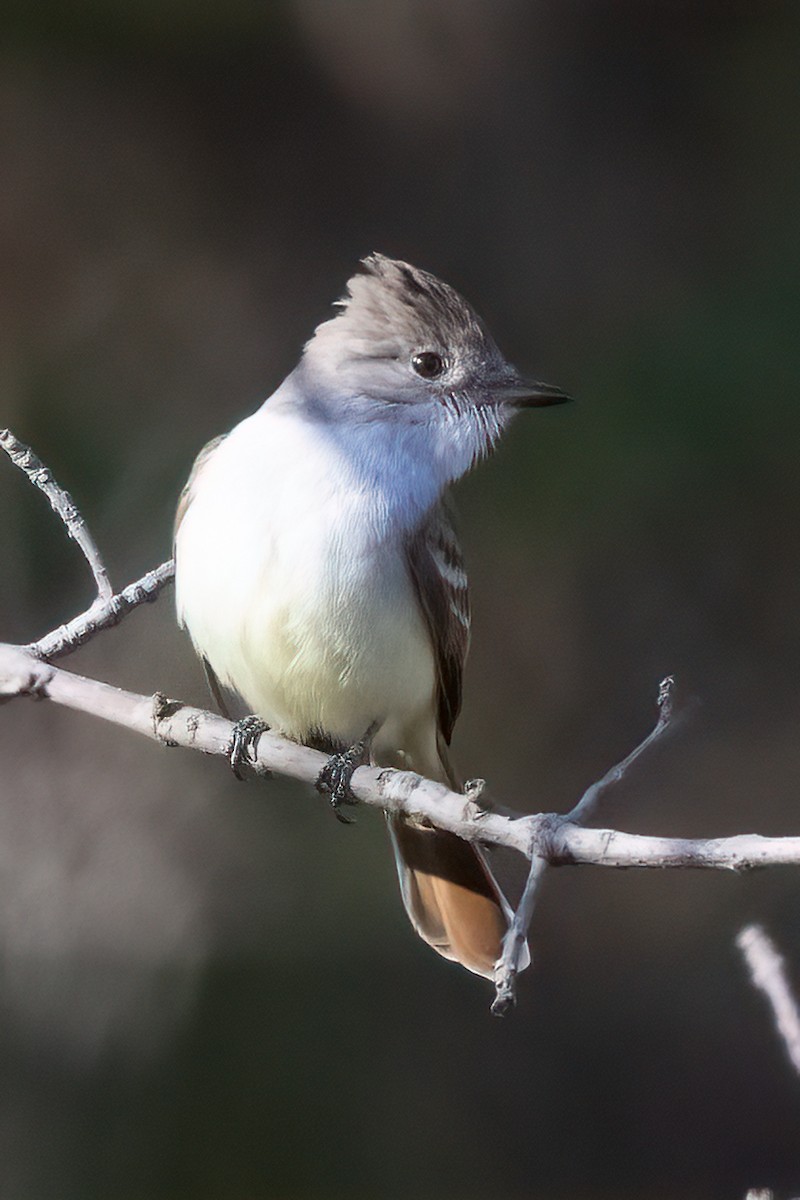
[387, 748, 529, 979]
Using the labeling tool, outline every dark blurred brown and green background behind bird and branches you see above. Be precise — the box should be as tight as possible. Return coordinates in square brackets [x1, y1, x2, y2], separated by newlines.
[0, 0, 800, 1200]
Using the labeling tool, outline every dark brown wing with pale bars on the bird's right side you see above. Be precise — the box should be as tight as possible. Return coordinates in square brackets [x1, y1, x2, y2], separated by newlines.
[405, 500, 470, 745]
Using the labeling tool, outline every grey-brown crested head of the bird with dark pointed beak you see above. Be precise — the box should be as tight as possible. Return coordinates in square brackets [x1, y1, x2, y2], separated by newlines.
[287, 254, 570, 478]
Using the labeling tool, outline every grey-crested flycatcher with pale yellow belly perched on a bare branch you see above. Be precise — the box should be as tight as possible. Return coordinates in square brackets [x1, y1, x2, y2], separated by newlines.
[175, 254, 569, 978]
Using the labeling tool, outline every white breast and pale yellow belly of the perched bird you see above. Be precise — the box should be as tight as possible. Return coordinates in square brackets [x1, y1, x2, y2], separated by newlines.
[175, 407, 435, 748]
